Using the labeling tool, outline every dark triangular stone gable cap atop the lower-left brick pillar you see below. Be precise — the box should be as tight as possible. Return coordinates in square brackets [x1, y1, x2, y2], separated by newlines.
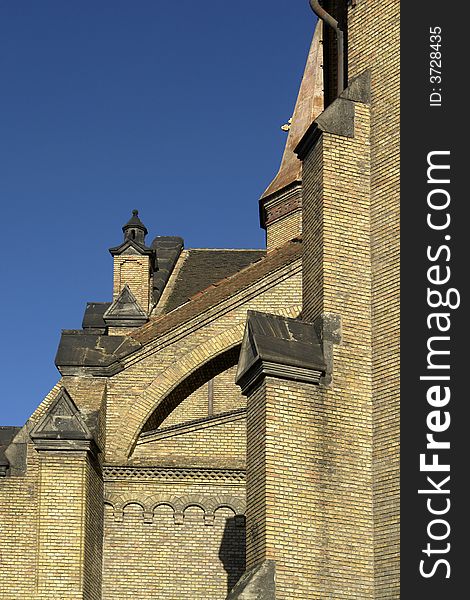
[31, 387, 93, 440]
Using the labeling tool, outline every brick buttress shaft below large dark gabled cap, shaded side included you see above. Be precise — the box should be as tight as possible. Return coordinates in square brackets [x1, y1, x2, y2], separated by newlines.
[247, 377, 326, 600]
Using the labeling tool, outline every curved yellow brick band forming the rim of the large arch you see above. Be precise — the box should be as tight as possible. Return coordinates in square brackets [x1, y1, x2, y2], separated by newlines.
[121, 323, 245, 457]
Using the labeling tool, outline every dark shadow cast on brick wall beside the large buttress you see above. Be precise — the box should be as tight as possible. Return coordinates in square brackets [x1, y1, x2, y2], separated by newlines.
[219, 515, 245, 593]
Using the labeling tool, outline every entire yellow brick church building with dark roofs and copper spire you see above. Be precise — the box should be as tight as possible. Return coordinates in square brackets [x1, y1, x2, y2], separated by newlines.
[0, 0, 399, 600]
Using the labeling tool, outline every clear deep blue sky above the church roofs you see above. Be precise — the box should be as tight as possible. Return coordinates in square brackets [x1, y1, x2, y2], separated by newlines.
[0, 0, 314, 425]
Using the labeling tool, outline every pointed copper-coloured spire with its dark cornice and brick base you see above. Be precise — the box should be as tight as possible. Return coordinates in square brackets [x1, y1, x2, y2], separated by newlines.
[260, 21, 323, 250]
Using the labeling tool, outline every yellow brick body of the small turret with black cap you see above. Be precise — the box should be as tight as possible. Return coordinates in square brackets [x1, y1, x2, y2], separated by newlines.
[113, 254, 151, 312]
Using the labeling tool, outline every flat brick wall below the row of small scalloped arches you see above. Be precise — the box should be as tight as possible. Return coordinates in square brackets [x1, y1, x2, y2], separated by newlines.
[103, 504, 245, 600]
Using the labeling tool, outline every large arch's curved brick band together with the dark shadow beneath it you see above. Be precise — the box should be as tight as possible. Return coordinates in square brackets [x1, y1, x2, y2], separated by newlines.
[125, 323, 245, 457]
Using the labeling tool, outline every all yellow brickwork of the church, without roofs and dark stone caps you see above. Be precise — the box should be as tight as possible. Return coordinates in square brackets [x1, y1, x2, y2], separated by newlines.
[0, 0, 399, 600]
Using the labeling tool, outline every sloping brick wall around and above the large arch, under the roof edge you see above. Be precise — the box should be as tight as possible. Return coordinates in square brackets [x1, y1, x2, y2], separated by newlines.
[105, 261, 301, 464]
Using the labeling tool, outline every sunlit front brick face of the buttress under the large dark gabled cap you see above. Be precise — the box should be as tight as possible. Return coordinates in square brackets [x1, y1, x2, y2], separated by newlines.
[265, 378, 324, 600]
